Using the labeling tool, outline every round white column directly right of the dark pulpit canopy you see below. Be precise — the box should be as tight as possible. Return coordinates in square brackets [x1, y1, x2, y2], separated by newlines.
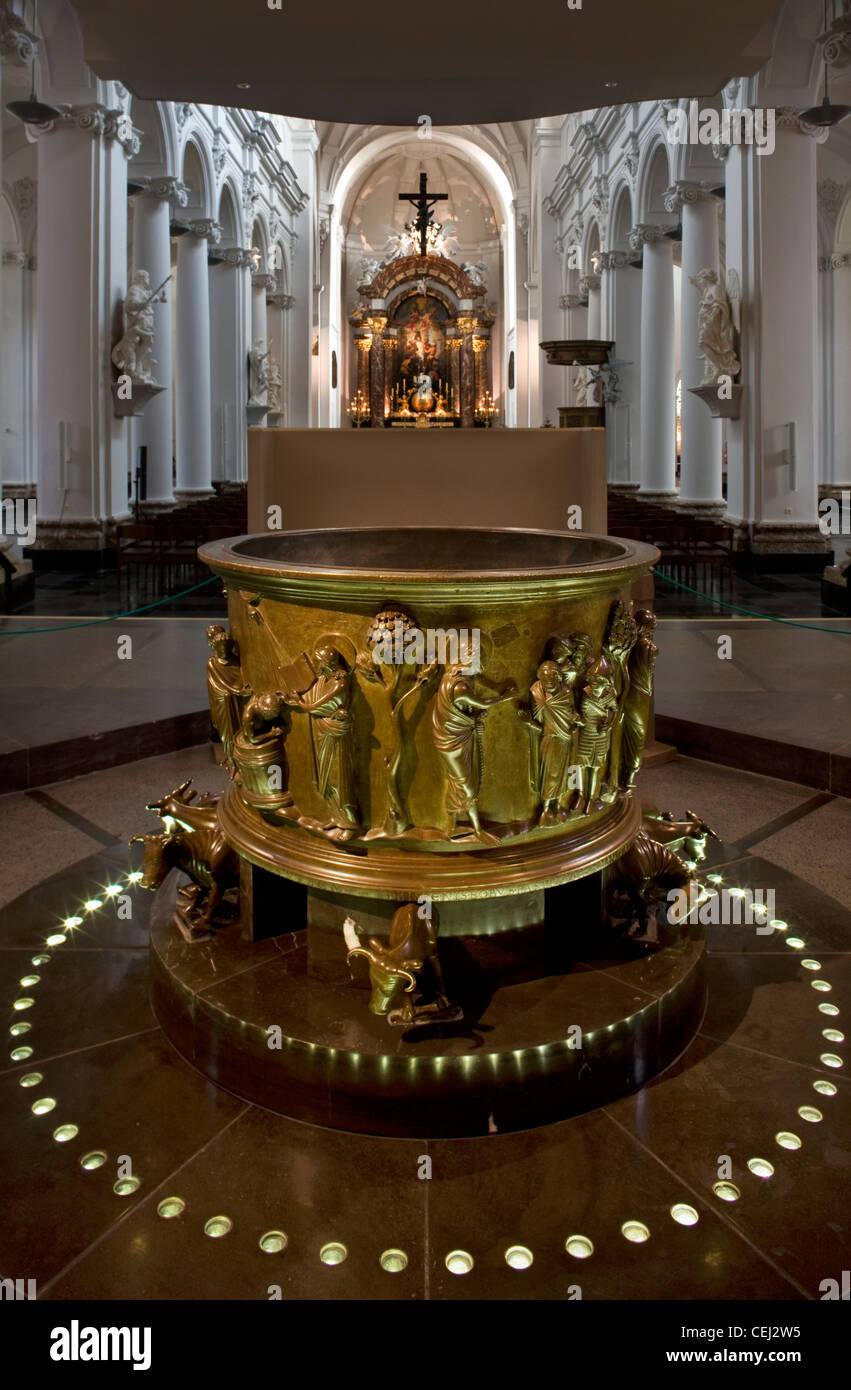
[599, 252, 641, 492]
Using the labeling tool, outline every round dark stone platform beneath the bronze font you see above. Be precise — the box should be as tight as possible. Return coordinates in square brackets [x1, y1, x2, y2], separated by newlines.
[150, 872, 705, 1137]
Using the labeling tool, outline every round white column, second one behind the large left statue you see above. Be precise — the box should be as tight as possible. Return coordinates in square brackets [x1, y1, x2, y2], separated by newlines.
[174, 218, 221, 500]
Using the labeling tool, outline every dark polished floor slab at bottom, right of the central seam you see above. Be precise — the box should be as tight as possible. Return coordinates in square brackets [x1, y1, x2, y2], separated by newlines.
[430, 1111, 800, 1300]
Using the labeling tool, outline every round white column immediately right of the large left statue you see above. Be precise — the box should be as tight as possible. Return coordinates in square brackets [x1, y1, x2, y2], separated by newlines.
[132, 177, 186, 507]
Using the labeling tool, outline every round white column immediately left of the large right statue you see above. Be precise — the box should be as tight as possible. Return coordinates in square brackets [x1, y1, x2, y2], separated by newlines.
[665, 181, 724, 516]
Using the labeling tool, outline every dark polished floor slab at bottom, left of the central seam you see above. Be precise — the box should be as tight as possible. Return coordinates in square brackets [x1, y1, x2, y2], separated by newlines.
[49, 1109, 428, 1301]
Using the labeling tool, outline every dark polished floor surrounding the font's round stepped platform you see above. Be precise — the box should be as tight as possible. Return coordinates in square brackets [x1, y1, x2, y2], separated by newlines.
[0, 746, 851, 1302]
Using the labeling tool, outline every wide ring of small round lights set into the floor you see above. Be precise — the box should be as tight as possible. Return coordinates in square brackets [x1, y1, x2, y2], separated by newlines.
[8, 872, 843, 1278]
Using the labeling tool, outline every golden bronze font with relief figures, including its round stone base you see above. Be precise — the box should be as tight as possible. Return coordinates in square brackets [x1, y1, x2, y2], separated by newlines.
[138, 525, 711, 1136]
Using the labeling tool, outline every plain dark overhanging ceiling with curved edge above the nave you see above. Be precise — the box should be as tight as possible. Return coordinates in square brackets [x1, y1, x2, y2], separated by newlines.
[74, 0, 779, 129]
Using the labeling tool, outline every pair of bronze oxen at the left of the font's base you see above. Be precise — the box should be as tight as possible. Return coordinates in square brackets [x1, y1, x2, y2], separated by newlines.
[129, 778, 239, 931]
